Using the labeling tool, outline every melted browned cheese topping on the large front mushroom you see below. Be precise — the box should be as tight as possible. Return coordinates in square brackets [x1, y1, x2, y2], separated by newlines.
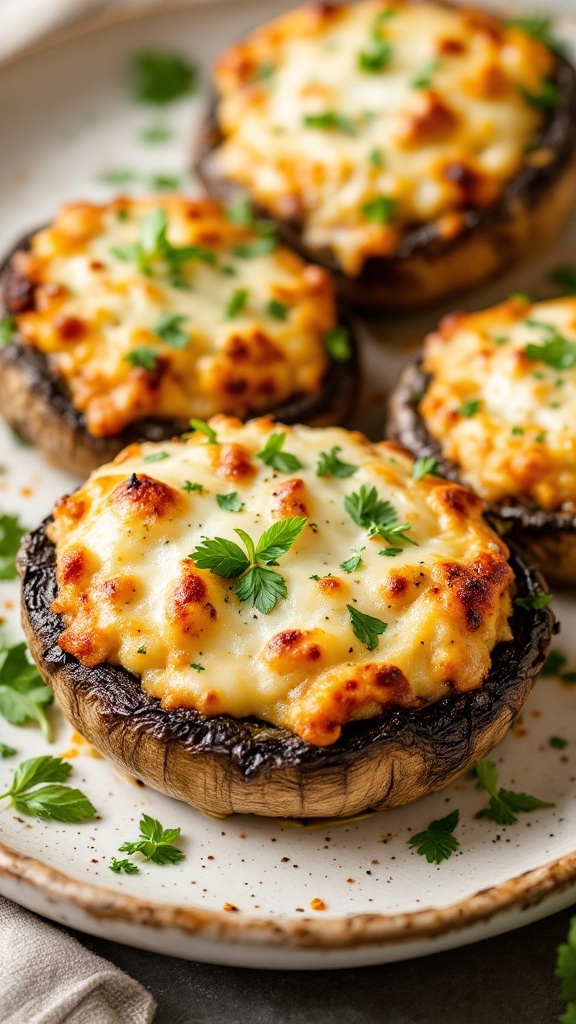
[48, 417, 513, 745]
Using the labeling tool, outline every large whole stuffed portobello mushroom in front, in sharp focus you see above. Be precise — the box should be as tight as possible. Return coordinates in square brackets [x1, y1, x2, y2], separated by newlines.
[19, 417, 553, 817]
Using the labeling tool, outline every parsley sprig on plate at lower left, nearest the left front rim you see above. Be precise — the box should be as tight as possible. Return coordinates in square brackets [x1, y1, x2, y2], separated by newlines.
[0, 754, 96, 822]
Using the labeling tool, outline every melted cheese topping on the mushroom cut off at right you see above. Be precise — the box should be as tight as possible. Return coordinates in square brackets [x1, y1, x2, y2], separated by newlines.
[420, 298, 576, 512]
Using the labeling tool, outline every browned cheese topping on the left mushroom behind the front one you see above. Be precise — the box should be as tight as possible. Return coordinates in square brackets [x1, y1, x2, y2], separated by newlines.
[14, 198, 336, 436]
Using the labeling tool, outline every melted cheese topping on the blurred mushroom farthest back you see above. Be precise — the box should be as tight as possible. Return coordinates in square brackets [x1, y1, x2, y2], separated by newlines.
[211, 0, 553, 276]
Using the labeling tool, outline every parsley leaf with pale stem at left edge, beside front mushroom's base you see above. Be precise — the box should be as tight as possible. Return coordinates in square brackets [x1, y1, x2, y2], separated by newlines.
[0, 642, 53, 741]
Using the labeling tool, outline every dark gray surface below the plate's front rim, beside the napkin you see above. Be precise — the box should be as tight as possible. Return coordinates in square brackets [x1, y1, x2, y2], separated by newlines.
[63, 910, 574, 1024]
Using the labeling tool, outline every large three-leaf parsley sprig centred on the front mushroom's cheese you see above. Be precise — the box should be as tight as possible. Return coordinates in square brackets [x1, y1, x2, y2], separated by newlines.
[189, 516, 307, 615]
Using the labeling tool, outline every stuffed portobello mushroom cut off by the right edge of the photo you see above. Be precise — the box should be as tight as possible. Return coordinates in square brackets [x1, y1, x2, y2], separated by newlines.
[388, 295, 576, 587]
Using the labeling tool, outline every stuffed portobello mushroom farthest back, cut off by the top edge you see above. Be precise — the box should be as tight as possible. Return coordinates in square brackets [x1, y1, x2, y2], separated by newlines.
[197, 0, 576, 309]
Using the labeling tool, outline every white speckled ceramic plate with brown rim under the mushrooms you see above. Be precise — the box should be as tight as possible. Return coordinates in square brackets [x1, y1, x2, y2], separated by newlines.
[0, 0, 576, 969]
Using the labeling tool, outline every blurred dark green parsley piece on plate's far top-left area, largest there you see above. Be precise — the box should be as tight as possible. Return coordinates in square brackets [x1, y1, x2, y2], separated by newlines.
[131, 50, 199, 106]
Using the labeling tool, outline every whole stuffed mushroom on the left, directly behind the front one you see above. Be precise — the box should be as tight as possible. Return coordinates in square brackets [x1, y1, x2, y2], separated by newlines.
[0, 197, 359, 476]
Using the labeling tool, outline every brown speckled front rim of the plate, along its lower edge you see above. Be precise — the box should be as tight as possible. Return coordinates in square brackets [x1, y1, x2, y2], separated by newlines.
[0, 843, 576, 950]
